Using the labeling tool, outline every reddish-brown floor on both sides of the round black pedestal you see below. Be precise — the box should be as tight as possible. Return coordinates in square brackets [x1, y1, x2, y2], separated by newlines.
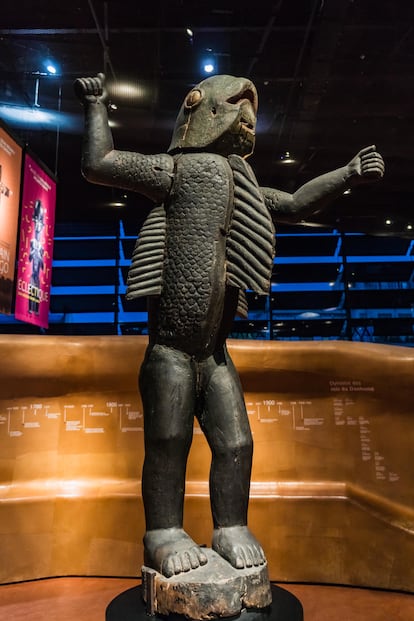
[0, 578, 414, 621]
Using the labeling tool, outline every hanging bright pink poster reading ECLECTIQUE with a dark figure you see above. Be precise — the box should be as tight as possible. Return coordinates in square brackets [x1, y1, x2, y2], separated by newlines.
[15, 155, 56, 328]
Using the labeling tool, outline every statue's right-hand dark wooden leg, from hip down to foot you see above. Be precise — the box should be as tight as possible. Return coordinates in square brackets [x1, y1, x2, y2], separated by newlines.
[199, 350, 266, 569]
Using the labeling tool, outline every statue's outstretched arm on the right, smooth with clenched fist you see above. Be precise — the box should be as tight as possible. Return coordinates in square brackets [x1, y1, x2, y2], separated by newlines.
[261, 145, 384, 223]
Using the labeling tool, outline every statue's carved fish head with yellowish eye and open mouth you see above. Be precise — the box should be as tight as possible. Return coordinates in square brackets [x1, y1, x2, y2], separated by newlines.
[168, 75, 257, 157]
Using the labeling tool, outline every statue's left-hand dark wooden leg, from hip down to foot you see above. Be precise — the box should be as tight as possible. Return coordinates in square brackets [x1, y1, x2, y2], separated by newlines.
[140, 345, 207, 577]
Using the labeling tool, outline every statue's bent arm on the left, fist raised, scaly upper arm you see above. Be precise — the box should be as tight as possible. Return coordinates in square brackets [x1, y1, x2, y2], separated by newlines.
[74, 73, 174, 202]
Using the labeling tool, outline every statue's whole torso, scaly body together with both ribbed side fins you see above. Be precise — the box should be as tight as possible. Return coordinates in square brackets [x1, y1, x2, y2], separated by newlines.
[128, 153, 273, 357]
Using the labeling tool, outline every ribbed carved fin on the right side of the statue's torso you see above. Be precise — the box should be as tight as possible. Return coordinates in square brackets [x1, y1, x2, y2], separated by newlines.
[227, 155, 275, 300]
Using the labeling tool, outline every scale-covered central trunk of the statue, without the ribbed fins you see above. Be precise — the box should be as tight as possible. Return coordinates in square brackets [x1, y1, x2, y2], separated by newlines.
[157, 153, 231, 350]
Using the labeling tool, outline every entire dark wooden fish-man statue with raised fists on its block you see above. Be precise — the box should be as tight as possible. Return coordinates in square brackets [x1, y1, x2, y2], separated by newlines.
[75, 74, 384, 617]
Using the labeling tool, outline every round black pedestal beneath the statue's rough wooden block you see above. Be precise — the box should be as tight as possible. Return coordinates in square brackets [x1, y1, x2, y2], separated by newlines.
[105, 585, 303, 621]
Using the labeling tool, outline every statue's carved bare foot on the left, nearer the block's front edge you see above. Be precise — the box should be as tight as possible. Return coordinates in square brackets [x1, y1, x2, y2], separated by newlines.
[144, 528, 207, 578]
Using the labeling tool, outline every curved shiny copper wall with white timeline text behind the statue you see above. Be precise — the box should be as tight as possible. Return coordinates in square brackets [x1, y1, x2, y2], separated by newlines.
[0, 336, 414, 591]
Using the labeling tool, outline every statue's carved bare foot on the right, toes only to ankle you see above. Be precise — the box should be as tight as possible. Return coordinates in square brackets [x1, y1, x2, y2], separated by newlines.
[212, 526, 266, 569]
